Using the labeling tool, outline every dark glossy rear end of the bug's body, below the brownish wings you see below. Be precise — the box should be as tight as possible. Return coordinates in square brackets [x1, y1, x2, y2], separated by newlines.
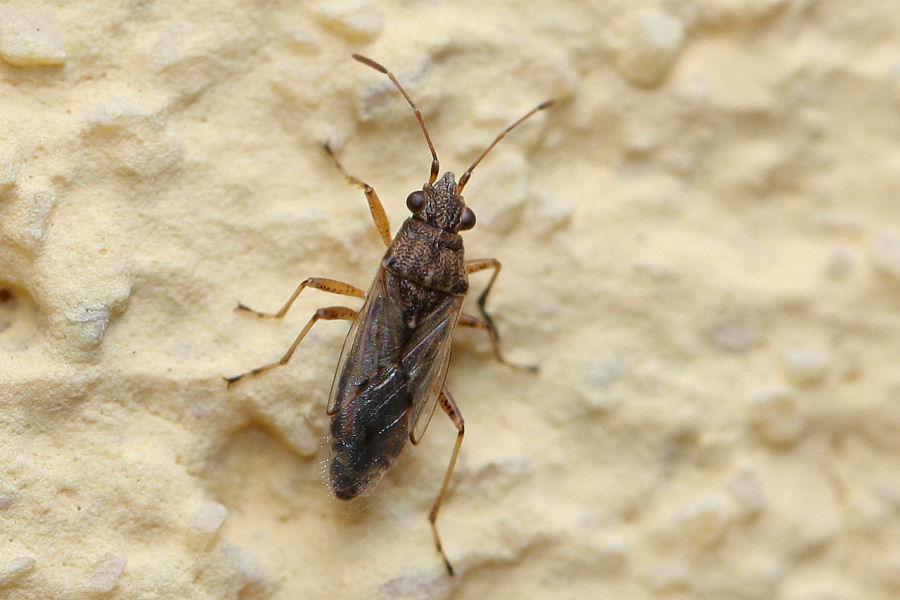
[330, 367, 409, 500]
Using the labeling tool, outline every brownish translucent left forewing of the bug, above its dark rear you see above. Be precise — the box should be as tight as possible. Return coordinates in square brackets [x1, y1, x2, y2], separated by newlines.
[327, 267, 408, 415]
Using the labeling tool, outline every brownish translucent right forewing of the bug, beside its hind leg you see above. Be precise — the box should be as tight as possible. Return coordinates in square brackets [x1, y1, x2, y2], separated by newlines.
[401, 296, 463, 444]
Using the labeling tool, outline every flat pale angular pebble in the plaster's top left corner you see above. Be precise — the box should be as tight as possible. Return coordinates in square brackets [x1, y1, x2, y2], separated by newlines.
[0, 6, 66, 67]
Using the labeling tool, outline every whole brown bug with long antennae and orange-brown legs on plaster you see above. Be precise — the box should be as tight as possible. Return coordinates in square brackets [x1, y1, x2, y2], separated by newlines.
[227, 54, 552, 575]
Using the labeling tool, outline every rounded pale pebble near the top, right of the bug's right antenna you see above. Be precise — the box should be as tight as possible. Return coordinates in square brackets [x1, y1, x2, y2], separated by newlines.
[618, 10, 684, 86]
